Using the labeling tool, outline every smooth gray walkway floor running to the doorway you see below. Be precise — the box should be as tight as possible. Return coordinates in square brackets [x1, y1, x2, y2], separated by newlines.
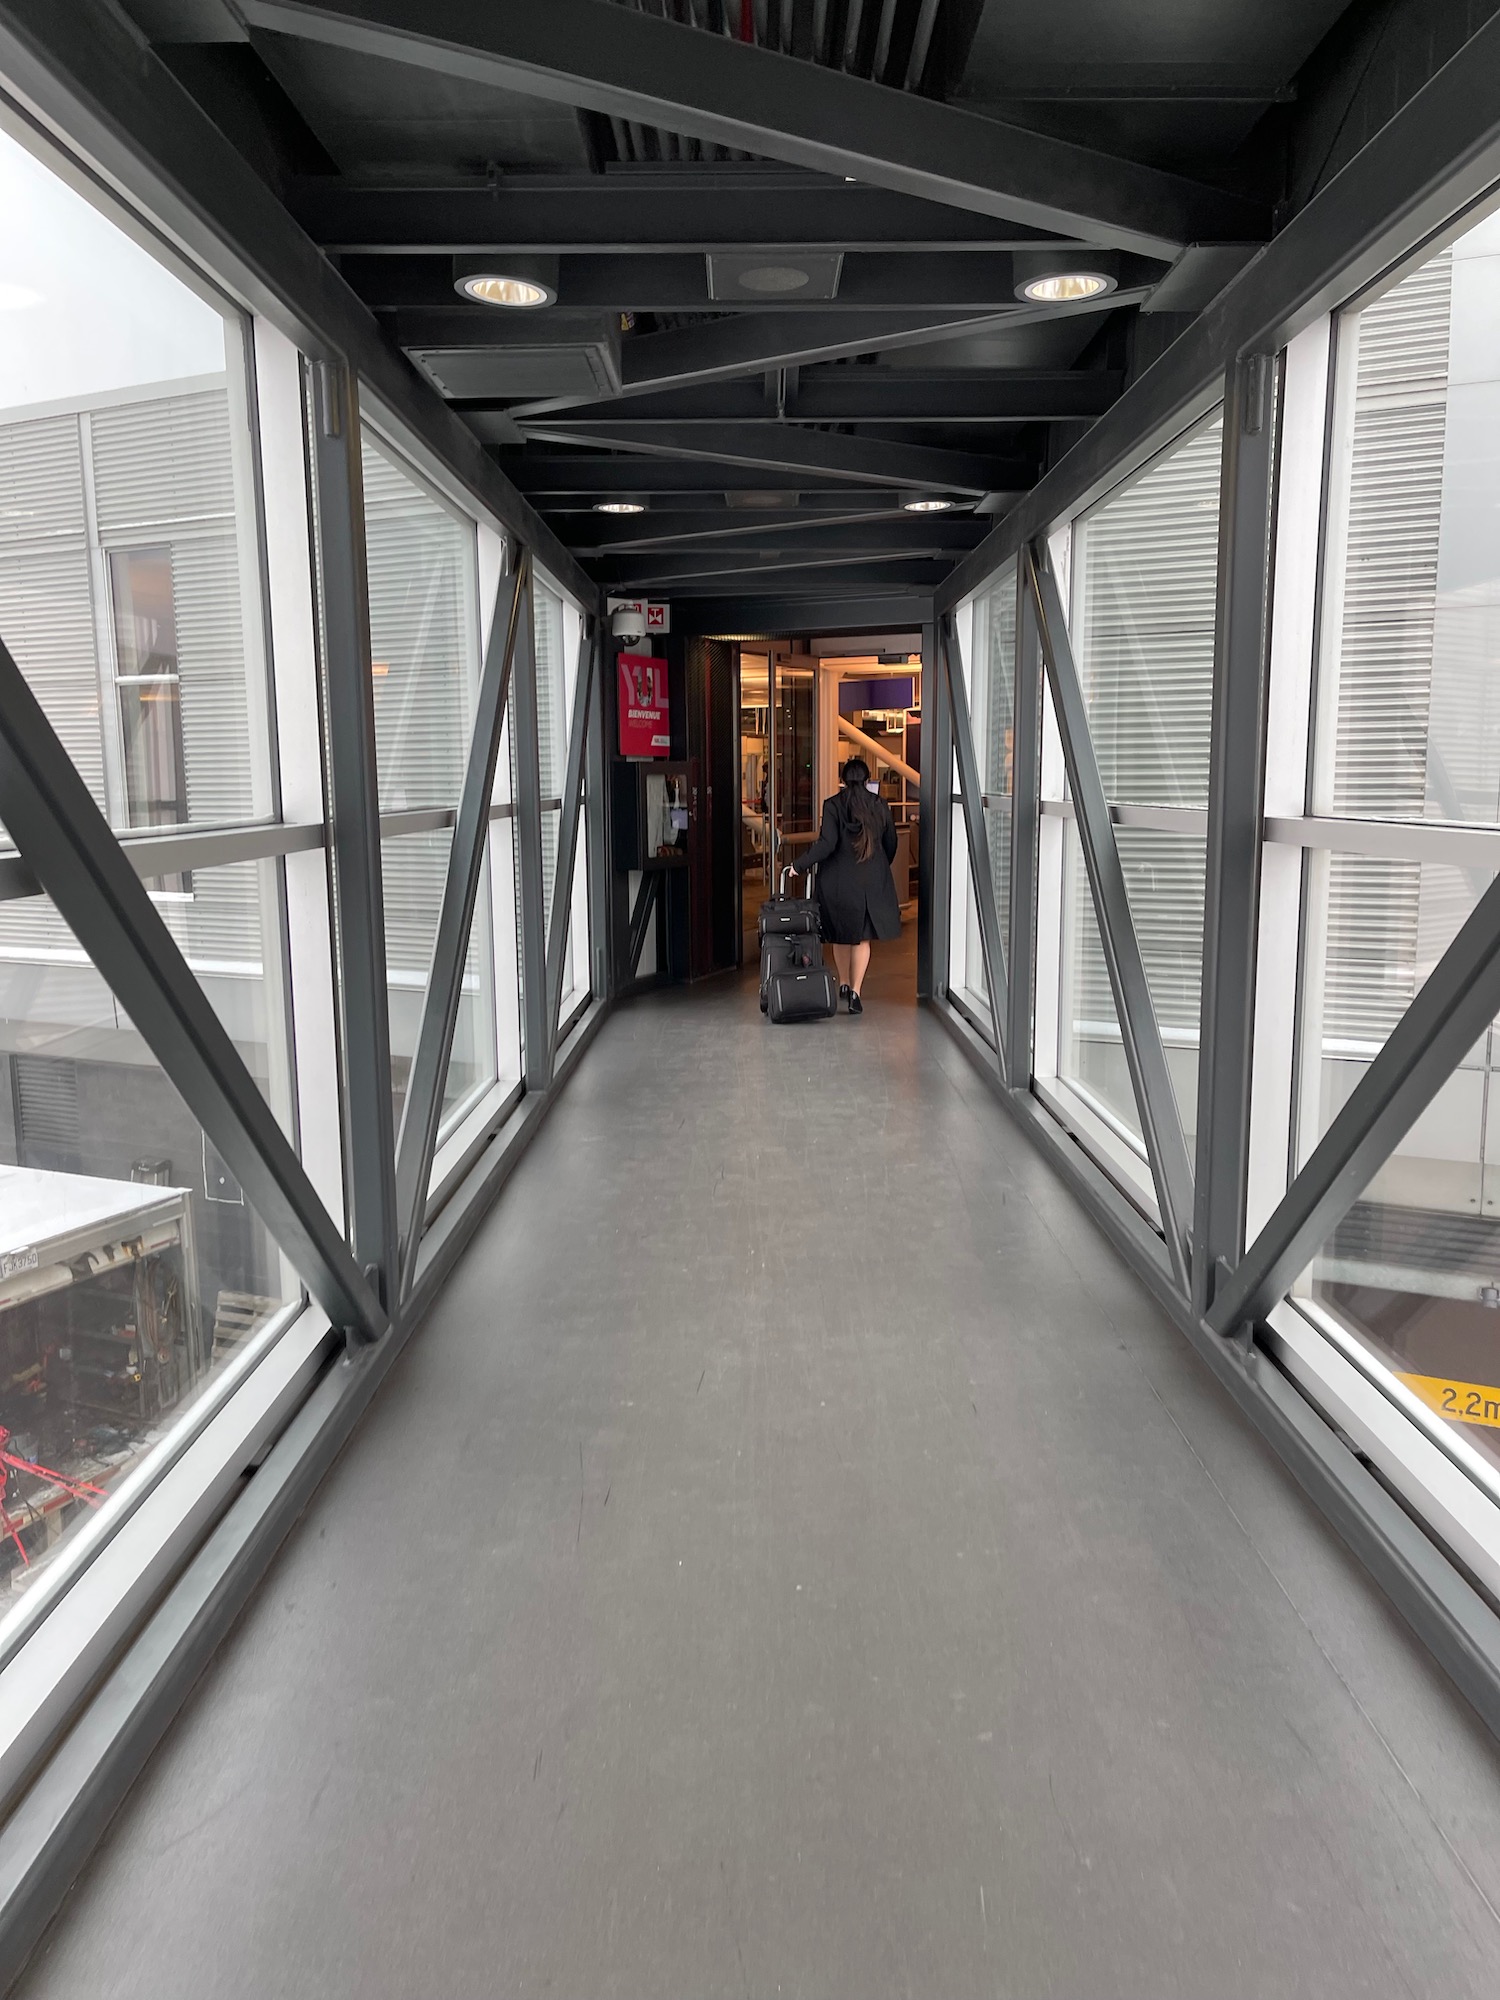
[22, 940, 1500, 2000]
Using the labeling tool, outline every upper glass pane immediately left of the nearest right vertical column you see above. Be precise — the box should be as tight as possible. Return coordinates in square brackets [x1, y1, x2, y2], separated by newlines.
[1072, 414, 1224, 806]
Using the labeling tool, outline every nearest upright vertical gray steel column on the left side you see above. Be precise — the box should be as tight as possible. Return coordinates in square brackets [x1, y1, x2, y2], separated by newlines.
[308, 362, 400, 1310]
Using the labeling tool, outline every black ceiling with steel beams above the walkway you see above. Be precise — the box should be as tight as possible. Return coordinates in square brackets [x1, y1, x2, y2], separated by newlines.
[124, 0, 1492, 596]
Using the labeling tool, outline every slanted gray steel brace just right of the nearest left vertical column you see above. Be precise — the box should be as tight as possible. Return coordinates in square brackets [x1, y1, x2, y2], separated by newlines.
[396, 556, 526, 1300]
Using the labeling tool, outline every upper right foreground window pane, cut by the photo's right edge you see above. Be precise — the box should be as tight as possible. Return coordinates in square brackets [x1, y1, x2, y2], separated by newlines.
[1314, 216, 1500, 824]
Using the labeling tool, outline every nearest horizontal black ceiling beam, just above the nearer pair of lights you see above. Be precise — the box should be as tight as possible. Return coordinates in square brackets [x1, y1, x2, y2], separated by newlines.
[286, 166, 1072, 256]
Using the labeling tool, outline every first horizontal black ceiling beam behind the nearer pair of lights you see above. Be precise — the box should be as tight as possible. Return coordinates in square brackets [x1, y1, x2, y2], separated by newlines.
[488, 368, 1124, 426]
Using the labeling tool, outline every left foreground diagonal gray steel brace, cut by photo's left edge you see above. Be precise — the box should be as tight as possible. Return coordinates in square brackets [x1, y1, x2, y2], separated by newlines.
[0, 624, 386, 1340]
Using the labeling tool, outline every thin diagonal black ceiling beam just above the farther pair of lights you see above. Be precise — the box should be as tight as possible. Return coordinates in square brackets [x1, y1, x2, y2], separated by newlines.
[526, 418, 1034, 498]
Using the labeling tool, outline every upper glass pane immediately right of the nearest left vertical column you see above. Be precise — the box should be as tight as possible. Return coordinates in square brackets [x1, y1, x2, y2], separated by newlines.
[362, 428, 480, 812]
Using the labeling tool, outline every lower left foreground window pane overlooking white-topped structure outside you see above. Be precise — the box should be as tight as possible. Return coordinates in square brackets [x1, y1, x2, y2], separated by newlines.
[0, 862, 300, 1618]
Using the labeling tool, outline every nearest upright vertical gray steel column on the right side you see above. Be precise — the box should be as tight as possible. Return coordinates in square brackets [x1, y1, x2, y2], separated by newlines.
[1192, 354, 1276, 1314]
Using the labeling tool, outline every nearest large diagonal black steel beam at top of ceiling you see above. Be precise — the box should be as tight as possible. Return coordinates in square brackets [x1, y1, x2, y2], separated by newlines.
[240, 0, 1270, 258]
